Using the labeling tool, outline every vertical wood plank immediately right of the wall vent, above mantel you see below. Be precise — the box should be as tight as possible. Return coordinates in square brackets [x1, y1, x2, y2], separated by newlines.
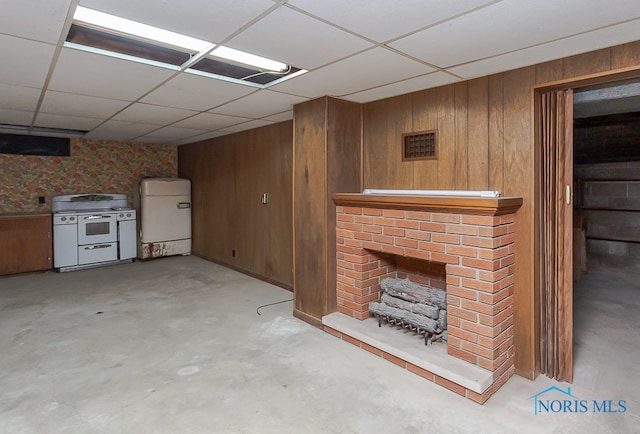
[437, 85, 456, 190]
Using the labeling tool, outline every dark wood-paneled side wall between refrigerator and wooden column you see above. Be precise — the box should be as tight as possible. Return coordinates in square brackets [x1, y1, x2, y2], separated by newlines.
[178, 121, 293, 288]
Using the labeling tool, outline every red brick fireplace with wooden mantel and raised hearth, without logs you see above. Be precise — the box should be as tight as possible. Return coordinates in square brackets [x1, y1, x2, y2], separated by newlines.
[323, 194, 522, 403]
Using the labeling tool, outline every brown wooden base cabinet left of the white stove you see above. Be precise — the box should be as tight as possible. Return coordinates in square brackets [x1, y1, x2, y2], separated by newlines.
[0, 213, 53, 275]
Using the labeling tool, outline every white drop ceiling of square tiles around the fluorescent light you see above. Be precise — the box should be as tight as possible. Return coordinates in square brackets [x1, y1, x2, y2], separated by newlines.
[0, 0, 640, 144]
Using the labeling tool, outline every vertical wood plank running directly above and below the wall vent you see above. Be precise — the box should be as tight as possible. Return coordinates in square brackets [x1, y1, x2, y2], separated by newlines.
[412, 89, 440, 190]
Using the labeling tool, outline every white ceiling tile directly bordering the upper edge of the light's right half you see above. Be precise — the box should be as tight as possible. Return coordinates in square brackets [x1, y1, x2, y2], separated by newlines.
[226, 7, 371, 69]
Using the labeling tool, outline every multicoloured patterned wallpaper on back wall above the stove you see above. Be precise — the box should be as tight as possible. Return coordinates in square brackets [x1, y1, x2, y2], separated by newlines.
[0, 139, 178, 214]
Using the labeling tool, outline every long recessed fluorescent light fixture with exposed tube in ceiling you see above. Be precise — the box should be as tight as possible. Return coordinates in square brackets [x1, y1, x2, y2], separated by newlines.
[66, 6, 306, 87]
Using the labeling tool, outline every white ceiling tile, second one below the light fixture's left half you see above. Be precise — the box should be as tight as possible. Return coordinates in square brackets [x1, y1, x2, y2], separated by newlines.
[40, 91, 130, 118]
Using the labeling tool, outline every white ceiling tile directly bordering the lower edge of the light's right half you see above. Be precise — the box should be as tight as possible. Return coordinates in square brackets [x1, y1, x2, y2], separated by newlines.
[141, 73, 256, 111]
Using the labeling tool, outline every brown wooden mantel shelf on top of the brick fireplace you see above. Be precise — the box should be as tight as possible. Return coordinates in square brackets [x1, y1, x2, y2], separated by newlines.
[333, 193, 522, 216]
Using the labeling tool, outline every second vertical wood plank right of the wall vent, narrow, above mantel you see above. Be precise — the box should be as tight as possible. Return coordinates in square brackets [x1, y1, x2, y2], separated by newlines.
[454, 81, 469, 190]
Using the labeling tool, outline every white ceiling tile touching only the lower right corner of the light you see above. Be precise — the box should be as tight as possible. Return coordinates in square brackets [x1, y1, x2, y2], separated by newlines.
[211, 90, 306, 118]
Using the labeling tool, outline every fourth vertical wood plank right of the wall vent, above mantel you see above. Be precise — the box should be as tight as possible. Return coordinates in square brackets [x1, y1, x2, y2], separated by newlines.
[489, 74, 505, 191]
